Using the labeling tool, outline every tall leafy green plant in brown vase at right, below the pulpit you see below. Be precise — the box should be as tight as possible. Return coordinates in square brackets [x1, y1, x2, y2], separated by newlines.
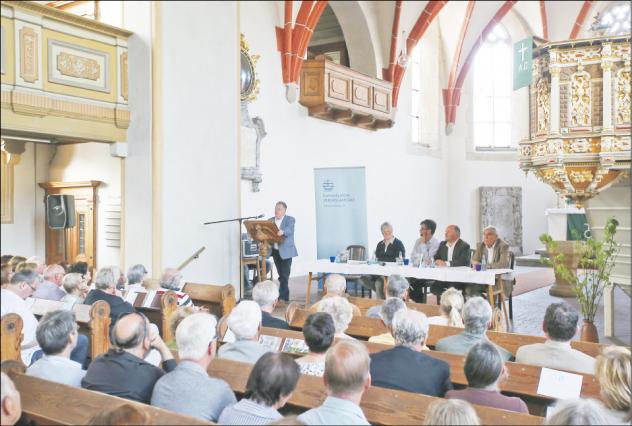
[540, 217, 619, 342]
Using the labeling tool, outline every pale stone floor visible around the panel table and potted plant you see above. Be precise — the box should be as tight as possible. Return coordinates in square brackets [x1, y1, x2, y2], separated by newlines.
[275, 267, 632, 346]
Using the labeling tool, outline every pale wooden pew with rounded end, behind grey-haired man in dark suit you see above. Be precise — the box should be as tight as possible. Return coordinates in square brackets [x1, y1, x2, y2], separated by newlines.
[30, 299, 110, 359]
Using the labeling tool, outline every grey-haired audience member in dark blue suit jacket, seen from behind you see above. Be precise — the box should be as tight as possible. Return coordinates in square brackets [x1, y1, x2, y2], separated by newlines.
[371, 310, 452, 397]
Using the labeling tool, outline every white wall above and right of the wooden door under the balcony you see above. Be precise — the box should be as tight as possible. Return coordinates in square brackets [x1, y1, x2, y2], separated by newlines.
[49, 142, 121, 268]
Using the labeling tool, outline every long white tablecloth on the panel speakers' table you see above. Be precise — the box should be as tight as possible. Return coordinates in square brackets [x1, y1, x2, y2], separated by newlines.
[292, 260, 512, 285]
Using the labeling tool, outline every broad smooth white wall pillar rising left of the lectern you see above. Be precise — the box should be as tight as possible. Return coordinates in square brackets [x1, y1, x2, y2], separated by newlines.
[159, 2, 241, 287]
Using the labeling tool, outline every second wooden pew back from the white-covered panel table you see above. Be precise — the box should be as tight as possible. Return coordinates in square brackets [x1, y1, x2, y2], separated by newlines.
[288, 309, 604, 357]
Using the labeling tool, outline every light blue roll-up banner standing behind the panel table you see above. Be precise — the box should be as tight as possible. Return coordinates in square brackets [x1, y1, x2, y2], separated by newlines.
[314, 167, 368, 259]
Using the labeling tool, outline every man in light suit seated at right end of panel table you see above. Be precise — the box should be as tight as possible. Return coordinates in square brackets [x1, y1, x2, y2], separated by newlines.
[465, 226, 513, 297]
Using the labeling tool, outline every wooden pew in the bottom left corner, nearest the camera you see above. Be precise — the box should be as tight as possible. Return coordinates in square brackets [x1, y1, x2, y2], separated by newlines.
[1, 364, 213, 425]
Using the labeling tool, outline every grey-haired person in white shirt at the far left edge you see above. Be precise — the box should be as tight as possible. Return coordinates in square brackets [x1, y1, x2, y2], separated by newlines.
[0, 269, 40, 365]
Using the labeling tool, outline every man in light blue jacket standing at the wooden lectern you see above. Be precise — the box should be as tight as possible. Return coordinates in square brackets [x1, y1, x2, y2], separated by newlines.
[270, 201, 298, 302]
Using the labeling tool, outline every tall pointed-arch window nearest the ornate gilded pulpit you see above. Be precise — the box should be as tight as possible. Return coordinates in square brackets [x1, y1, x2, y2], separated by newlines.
[473, 24, 513, 151]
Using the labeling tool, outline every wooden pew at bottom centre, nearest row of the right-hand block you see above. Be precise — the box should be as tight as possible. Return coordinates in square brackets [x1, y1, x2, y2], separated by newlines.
[207, 359, 544, 425]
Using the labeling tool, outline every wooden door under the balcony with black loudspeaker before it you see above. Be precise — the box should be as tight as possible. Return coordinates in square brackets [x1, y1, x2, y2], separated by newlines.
[39, 181, 101, 268]
